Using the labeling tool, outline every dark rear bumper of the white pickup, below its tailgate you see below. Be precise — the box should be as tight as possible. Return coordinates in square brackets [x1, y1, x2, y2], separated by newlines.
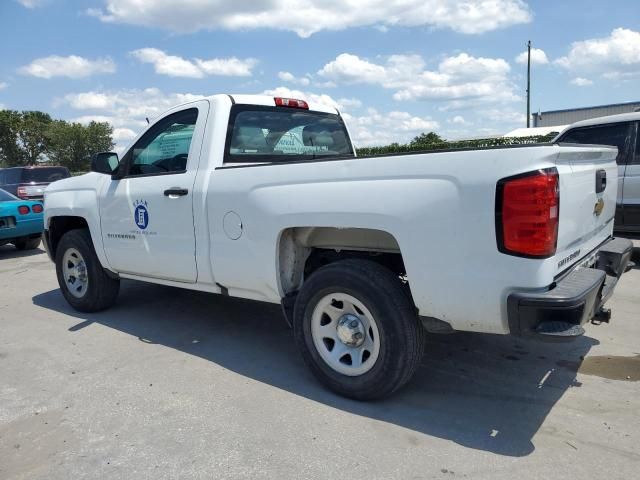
[507, 238, 633, 336]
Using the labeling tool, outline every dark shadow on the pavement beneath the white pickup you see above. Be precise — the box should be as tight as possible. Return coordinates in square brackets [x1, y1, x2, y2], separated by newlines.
[33, 282, 597, 457]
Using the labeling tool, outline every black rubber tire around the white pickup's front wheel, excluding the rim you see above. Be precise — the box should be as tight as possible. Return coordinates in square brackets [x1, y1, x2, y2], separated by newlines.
[56, 229, 120, 313]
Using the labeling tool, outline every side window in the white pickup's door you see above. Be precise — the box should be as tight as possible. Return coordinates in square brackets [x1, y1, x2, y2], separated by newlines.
[127, 108, 198, 176]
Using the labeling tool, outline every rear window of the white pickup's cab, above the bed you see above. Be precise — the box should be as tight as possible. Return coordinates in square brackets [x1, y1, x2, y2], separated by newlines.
[225, 105, 353, 163]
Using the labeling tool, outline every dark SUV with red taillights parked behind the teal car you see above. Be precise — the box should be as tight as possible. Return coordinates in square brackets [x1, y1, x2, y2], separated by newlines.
[0, 167, 71, 200]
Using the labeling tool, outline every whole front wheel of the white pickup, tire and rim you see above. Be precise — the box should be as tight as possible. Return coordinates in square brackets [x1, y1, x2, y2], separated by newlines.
[56, 230, 120, 312]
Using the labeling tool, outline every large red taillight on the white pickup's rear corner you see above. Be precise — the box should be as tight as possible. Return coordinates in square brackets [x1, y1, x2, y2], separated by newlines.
[496, 168, 560, 258]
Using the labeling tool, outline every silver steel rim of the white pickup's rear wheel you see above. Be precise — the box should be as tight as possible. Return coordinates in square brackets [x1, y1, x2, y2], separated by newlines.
[311, 292, 380, 377]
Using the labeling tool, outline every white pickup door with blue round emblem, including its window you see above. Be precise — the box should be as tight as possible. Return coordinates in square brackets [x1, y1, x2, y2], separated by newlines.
[99, 100, 209, 282]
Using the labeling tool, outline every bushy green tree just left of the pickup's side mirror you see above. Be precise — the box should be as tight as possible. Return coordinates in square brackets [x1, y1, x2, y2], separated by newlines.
[47, 120, 114, 172]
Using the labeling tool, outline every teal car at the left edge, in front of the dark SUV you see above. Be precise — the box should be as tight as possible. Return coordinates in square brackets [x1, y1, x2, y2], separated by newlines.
[0, 190, 44, 250]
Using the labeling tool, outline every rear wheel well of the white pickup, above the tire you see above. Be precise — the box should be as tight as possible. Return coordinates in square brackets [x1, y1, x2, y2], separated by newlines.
[278, 227, 406, 295]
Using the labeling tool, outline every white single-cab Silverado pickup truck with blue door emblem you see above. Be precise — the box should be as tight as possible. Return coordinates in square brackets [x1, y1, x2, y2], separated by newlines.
[44, 95, 632, 399]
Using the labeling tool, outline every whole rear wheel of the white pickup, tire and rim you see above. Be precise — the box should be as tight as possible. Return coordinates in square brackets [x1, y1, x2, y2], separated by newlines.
[294, 259, 424, 400]
